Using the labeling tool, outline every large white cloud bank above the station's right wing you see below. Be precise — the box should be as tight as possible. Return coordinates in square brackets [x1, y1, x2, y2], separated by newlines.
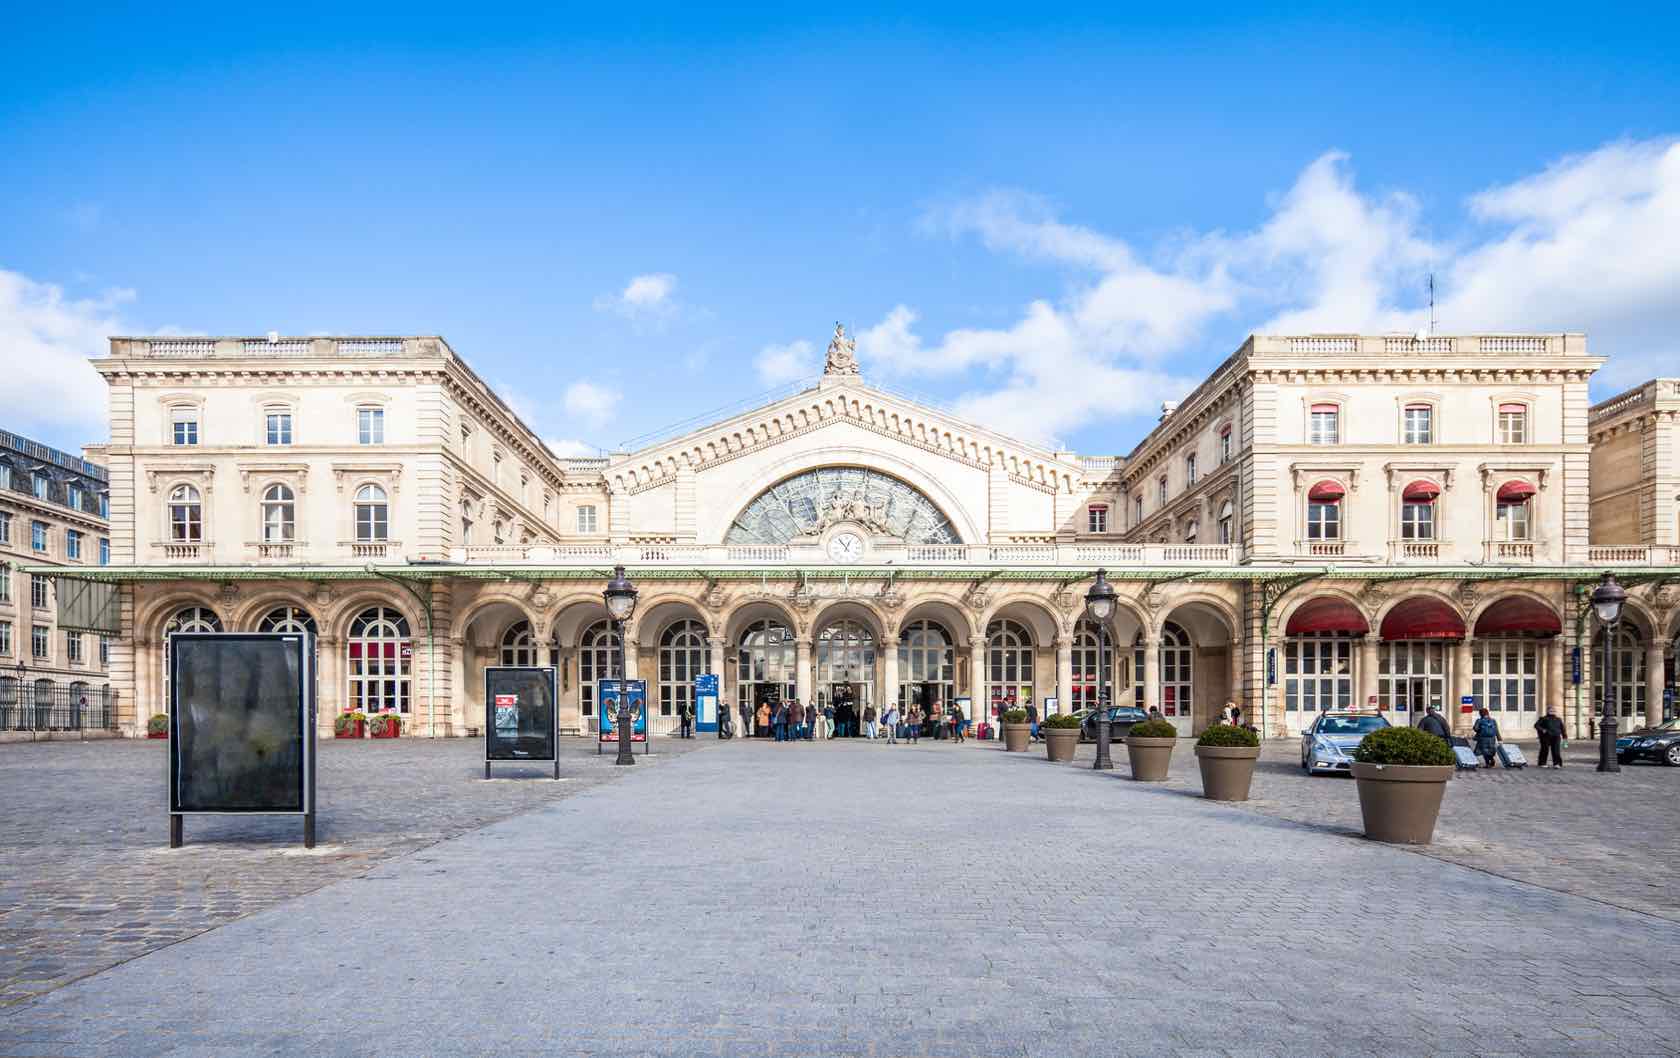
[866, 139, 1680, 437]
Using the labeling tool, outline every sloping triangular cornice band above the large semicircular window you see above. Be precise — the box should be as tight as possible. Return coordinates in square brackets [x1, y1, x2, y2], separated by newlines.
[605, 376, 1084, 492]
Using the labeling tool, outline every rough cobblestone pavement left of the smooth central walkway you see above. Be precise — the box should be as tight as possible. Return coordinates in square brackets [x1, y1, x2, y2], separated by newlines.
[0, 739, 709, 1008]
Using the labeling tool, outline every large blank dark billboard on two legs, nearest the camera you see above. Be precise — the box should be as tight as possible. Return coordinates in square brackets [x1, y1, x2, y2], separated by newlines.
[166, 631, 316, 848]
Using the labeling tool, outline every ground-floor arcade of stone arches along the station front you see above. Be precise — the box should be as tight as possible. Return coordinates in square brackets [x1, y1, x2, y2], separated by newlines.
[115, 569, 1680, 737]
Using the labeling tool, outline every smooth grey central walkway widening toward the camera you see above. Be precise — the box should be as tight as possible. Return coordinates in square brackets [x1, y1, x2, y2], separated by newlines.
[0, 742, 1680, 1056]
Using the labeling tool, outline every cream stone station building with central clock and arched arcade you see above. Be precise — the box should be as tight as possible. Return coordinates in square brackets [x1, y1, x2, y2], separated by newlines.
[36, 329, 1680, 737]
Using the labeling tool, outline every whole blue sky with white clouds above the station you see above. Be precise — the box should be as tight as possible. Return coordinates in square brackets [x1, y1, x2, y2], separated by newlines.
[0, 5, 1680, 452]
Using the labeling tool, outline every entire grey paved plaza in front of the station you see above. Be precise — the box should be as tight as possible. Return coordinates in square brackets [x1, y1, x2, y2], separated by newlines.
[0, 741, 1680, 1056]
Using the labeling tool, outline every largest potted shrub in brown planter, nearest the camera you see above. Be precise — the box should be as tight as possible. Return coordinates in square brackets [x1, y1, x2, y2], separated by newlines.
[1352, 727, 1453, 845]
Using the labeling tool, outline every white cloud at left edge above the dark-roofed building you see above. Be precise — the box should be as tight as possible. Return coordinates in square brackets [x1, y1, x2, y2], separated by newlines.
[0, 269, 125, 452]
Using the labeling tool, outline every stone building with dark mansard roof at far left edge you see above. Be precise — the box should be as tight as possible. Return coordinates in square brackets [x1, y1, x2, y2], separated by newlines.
[0, 430, 118, 737]
